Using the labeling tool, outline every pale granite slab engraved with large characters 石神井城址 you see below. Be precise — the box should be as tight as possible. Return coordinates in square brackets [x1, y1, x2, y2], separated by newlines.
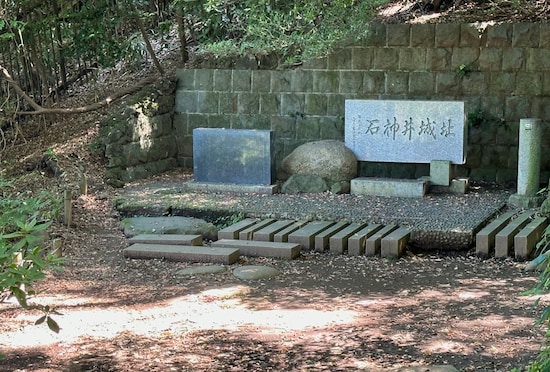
[345, 100, 467, 164]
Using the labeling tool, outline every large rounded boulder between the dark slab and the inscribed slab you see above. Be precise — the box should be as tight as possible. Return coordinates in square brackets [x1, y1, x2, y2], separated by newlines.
[281, 140, 357, 184]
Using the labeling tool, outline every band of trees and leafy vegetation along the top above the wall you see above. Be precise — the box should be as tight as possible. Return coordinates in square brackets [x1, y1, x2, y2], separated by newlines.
[0, 0, 389, 117]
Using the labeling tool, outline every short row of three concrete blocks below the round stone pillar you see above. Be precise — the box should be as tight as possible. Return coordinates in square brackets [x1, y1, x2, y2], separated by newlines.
[476, 210, 548, 260]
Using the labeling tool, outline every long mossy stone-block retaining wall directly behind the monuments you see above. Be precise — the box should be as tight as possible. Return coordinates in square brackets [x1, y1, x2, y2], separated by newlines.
[173, 23, 550, 182]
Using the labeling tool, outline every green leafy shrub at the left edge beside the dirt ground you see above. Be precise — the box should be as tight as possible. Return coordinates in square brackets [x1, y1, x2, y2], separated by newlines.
[0, 179, 62, 332]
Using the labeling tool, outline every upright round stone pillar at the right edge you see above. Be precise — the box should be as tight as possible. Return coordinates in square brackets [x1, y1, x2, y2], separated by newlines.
[509, 118, 543, 208]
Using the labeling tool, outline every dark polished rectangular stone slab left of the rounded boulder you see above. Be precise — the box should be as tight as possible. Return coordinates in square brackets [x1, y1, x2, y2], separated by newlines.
[193, 128, 275, 185]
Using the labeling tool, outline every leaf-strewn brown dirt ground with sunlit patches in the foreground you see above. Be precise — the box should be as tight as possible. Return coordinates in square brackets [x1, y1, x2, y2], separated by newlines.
[0, 190, 547, 371]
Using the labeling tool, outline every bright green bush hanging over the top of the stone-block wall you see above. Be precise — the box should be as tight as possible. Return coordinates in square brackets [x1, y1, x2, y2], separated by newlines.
[175, 0, 388, 64]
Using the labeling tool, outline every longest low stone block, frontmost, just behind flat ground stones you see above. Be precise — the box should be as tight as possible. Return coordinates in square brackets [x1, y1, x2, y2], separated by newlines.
[123, 243, 240, 265]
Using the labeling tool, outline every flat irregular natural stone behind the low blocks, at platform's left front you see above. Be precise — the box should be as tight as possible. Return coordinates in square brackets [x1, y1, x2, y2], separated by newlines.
[121, 217, 218, 240]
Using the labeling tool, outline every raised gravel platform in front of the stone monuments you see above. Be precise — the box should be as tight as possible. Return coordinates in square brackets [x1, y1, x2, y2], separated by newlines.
[116, 172, 511, 250]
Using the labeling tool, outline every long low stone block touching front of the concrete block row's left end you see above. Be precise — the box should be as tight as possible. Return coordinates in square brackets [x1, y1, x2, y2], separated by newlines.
[212, 239, 301, 259]
